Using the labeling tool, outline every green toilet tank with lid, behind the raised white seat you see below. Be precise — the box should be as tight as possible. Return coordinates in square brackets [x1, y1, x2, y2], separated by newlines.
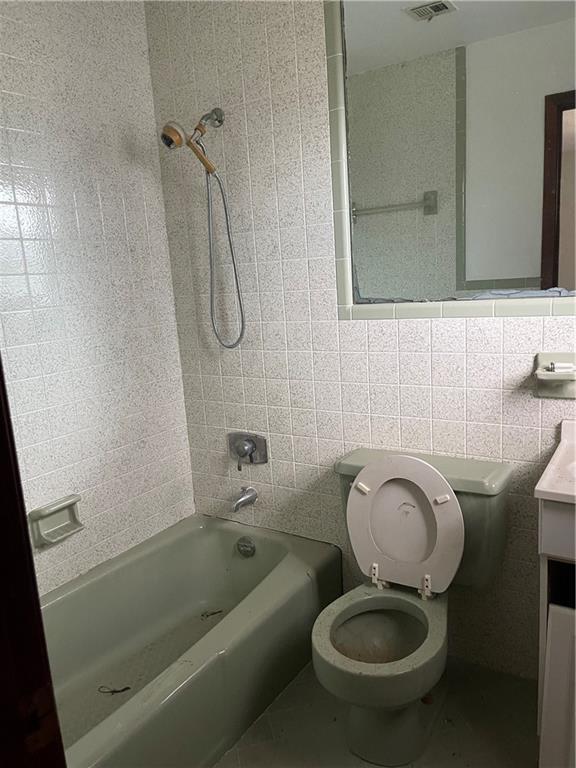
[334, 448, 512, 589]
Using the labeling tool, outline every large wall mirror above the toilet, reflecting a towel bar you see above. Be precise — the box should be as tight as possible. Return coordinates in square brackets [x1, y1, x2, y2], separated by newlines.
[342, 0, 575, 304]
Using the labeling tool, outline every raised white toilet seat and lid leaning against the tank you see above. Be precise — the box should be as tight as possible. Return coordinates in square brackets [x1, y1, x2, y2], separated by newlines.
[347, 455, 464, 592]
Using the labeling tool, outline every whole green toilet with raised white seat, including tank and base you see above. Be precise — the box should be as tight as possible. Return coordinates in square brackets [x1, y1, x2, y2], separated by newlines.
[312, 449, 511, 766]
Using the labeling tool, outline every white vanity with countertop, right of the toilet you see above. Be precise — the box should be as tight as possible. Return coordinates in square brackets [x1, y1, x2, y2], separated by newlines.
[534, 421, 576, 768]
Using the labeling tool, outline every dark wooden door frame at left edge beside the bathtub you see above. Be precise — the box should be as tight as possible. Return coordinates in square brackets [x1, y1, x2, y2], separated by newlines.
[0, 359, 66, 768]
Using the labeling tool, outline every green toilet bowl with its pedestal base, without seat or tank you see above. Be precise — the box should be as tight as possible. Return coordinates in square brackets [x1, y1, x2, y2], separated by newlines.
[312, 585, 447, 766]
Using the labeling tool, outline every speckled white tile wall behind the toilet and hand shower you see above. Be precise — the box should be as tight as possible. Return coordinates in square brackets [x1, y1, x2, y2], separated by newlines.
[146, 2, 576, 676]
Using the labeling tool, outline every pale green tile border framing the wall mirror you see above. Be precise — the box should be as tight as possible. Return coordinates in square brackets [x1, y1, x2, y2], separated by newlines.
[324, 0, 576, 320]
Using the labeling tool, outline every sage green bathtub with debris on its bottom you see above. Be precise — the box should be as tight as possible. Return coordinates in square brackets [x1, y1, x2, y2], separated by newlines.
[42, 515, 341, 768]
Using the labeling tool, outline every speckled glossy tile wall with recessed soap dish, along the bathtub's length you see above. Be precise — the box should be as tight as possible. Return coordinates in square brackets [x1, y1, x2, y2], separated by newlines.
[0, 2, 193, 592]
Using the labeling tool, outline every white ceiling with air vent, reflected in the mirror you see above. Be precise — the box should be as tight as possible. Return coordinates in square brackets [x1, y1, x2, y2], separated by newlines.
[344, 0, 575, 74]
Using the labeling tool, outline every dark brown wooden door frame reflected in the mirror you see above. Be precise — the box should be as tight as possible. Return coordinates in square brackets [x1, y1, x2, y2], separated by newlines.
[540, 91, 574, 288]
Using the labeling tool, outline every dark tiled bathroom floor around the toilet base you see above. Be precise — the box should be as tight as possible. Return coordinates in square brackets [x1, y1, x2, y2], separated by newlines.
[215, 660, 537, 768]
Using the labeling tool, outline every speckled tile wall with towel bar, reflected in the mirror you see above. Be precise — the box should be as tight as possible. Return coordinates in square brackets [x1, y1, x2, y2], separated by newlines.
[346, 49, 456, 299]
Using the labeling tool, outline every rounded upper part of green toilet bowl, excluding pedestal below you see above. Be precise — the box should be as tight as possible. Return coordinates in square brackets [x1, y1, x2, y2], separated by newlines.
[312, 585, 447, 707]
